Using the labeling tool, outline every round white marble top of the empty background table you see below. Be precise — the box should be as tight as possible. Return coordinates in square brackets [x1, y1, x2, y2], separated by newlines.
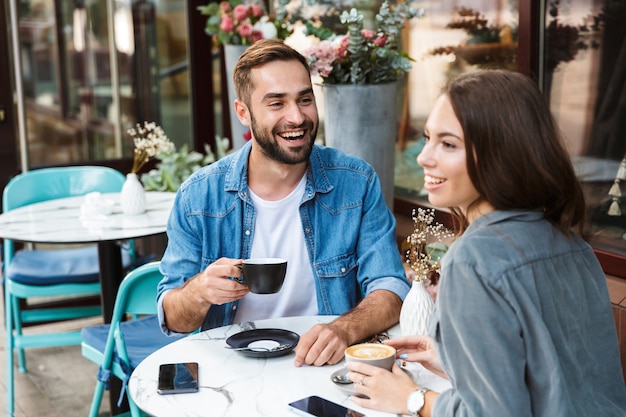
[0, 191, 176, 243]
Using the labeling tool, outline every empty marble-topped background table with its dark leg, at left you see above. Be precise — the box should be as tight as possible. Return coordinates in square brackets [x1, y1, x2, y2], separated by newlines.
[0, 192, 176, 323]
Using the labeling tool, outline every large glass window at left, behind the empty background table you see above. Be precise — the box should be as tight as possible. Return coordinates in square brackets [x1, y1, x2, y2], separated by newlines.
[18, 0, 192, 167]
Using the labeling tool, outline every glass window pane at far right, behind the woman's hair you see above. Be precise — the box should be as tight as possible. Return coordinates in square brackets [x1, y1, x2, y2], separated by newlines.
[543, 0, 626, 256]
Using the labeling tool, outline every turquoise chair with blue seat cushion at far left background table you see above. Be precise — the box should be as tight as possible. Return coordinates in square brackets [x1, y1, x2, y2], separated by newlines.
[2, 166, 133, 417]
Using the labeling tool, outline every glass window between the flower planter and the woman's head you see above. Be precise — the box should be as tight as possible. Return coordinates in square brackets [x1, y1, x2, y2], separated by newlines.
[395, 0, 519, 202]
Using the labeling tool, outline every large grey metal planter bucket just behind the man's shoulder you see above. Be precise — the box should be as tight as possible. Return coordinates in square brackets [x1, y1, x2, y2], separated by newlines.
[322, 82, 398, 208]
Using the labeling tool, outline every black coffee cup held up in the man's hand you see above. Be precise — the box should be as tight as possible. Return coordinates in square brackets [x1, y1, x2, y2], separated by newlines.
[237, 258, 287, 294]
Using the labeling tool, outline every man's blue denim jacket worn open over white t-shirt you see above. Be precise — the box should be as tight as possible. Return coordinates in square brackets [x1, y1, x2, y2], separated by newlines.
[157, 143, 410, 334]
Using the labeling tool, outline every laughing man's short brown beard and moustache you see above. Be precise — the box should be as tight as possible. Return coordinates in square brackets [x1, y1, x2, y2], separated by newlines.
[250, 115, 317, 165]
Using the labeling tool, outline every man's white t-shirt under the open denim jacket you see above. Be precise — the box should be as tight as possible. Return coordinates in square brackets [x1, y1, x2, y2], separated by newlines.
[235, 175, 318, 323]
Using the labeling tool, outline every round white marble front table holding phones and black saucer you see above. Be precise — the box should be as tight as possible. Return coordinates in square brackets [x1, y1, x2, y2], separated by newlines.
[128, 316, 449, 417]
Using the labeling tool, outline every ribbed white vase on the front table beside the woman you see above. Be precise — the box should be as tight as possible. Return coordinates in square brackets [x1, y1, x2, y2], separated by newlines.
[400, 280, 435, 336]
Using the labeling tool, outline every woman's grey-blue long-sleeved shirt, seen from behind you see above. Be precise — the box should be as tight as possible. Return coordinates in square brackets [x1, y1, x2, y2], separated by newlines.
[429, 211, 626, 417]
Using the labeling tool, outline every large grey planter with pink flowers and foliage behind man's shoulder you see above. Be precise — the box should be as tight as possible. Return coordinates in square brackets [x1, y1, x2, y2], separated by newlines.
[282, 1, 424, 207]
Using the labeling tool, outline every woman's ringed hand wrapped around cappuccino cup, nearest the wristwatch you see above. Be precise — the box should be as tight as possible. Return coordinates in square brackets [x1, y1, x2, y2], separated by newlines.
[347, 362, 418, 414]
